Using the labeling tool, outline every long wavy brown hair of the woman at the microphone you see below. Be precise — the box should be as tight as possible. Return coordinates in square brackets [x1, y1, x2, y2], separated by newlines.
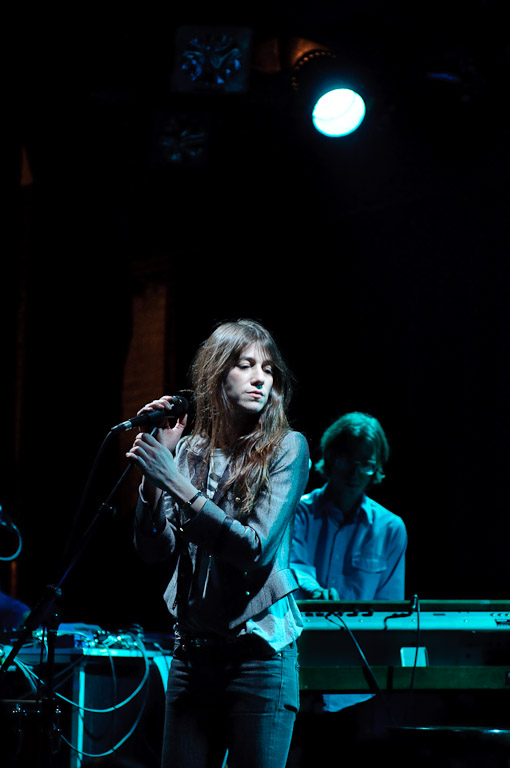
[190, 319, 292, 519]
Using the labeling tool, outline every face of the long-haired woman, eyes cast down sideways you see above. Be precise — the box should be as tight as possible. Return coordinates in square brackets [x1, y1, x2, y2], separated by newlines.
[224, 343, 273, 415]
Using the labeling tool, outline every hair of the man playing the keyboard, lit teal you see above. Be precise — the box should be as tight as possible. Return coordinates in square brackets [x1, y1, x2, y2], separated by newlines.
[315, 411, 390, 485]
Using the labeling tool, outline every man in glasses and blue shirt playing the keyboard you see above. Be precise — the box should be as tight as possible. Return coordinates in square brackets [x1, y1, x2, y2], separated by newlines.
[290, 412, 407, 760]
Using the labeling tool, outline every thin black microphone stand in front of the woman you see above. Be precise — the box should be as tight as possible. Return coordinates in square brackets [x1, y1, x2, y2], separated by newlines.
[0, 427, 143, 768]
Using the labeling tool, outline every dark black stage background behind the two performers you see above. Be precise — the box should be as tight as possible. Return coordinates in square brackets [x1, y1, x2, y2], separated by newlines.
[0, 1, 510, 628]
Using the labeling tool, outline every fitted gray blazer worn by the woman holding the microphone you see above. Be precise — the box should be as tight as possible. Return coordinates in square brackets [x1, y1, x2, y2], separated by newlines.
[135, 432, 309, 632]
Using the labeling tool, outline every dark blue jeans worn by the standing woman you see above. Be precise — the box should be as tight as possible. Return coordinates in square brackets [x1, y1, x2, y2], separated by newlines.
[162, 638, 299, 768]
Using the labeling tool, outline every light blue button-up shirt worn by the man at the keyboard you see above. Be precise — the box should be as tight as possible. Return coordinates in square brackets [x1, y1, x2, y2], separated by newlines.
[290, 484, 407, 711]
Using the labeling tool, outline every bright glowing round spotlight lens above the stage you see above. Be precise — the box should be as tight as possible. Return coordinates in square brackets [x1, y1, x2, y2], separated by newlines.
[312, 88, 366, 136]
